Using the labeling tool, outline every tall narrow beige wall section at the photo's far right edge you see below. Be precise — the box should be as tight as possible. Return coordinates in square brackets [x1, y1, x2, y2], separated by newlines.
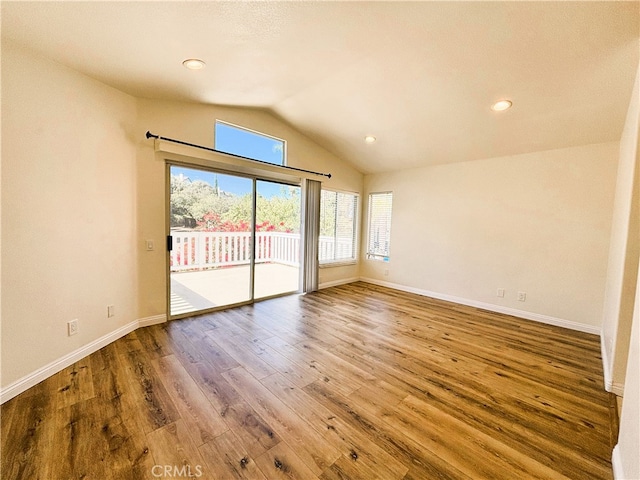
[602, 64, 640, 394]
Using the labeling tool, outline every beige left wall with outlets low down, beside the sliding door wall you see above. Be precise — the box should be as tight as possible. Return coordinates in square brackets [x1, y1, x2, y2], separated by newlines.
[2, 41, 138, 387]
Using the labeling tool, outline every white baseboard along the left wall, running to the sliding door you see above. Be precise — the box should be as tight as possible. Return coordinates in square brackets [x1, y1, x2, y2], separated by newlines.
[0, 315, 167, 405]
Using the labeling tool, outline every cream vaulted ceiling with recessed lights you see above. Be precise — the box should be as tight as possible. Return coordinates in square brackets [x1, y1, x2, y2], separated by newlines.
[2, 1, 640, 173]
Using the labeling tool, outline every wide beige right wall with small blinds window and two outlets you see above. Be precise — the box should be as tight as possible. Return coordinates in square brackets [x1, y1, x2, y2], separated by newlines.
[361, 143, 618, 332]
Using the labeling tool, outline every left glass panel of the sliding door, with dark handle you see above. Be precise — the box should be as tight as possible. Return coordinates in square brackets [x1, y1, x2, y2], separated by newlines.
[169, 165, 253, 316]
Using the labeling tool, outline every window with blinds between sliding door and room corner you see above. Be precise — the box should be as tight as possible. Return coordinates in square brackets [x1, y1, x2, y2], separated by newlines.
[318, 190, 358, 265]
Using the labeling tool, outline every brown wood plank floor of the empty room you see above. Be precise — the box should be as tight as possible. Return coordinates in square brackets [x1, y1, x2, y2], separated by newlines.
[1, 283, 612, 480]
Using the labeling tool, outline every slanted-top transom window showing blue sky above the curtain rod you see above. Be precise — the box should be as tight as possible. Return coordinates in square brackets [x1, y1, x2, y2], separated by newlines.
[213, 120, 286, 165]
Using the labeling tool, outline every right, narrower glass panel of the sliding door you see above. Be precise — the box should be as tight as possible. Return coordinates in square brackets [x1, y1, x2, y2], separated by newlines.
[254, 180, 300, 298]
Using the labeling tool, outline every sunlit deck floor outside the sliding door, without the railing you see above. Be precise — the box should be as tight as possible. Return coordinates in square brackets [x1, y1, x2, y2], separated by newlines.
[171, 263, 299, 315]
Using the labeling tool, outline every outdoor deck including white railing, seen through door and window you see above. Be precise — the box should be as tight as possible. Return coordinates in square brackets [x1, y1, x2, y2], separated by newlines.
[169, 230, 353, 315]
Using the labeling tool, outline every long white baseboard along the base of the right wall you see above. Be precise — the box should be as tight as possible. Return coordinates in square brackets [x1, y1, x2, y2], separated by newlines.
[360, 277, 601, 335]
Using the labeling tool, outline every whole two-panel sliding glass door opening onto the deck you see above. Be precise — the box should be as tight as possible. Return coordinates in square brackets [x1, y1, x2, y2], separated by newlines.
[168, 165, 300, 317]
